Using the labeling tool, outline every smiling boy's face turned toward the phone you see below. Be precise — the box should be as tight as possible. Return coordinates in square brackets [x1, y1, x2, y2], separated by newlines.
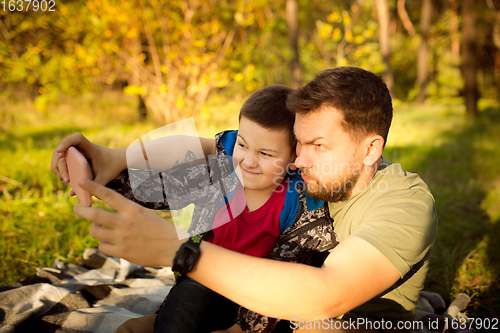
[233, 117, 295, 190]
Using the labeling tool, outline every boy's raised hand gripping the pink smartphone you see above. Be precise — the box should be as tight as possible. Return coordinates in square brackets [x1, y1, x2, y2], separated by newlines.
[50, 133, 126, 191]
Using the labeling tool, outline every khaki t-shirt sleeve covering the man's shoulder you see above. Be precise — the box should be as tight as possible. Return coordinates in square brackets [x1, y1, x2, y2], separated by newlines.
[352, 172, 437, 277]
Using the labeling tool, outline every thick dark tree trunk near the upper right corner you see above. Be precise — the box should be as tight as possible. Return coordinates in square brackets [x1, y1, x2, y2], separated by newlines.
[462, 0, 479, 118]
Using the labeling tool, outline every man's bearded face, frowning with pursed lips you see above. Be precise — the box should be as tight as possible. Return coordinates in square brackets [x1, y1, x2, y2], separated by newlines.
[294, 107, 364, 202]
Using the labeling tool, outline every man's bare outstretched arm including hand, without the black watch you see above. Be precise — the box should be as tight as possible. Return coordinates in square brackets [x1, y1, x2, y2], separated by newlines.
[74, 181, 401, 320]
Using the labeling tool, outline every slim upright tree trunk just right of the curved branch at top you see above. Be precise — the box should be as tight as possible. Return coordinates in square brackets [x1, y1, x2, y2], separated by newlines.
[417, 0, 432, 104]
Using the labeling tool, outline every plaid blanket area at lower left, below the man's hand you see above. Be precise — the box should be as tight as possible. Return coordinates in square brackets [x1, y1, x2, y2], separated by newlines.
[0, 249, 174, 333]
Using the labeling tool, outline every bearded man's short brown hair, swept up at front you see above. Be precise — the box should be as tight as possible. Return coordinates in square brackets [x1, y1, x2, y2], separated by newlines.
[287, 67, 392, 145]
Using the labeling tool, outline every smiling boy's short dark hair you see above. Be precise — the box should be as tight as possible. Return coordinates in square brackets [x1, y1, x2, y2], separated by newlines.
[238, 84, 296, 149]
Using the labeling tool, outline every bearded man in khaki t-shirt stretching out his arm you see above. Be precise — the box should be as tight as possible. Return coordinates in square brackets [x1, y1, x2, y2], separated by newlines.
[53, 67, 437, 331]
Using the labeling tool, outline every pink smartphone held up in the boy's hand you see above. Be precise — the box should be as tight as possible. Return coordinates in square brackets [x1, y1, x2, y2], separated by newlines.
[66, 147, 94, 207]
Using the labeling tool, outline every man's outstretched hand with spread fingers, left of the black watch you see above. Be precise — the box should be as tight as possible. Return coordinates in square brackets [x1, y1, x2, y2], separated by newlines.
[74, 180, 183, 266]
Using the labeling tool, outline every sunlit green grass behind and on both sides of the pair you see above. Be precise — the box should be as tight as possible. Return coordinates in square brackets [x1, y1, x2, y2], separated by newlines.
[0, 93, 500, 318]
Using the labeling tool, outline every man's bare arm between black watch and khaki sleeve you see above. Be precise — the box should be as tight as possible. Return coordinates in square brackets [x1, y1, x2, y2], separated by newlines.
[189, 232, 401, 320]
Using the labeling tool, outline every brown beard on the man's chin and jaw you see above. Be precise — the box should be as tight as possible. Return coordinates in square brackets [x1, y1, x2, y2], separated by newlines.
[302, 170, 360, 202]
